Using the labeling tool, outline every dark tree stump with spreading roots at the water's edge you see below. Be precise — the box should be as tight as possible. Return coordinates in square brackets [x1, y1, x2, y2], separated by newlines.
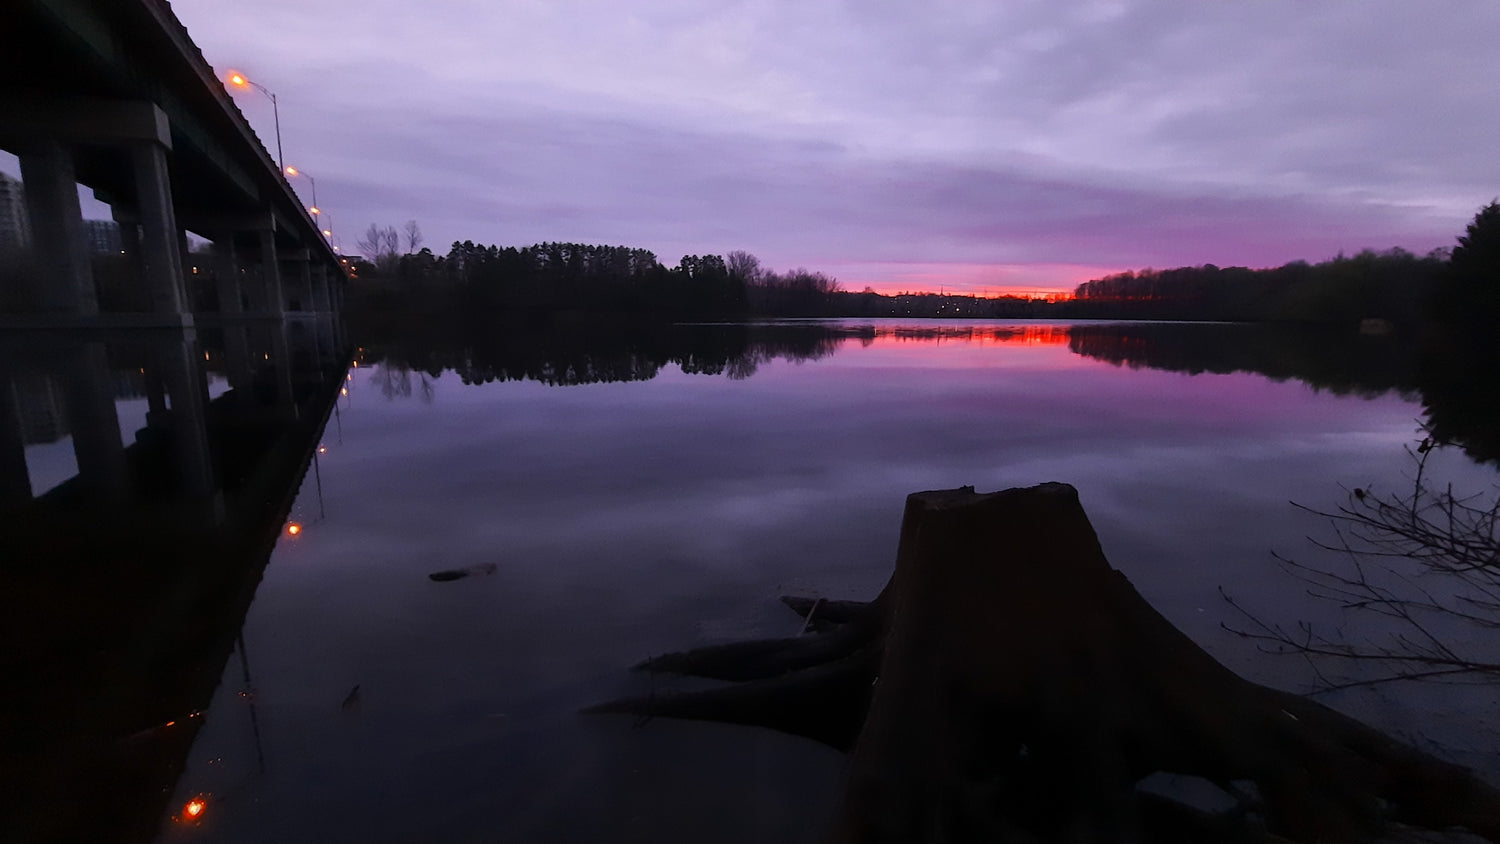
[594, 484, 1500, 844]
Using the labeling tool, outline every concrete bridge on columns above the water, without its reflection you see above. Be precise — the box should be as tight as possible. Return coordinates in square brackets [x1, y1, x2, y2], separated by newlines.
[0, 0, 347, 328]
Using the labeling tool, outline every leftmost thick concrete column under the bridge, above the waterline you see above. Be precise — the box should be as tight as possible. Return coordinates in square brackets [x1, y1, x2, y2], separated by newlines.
[20, 141, 99, 316]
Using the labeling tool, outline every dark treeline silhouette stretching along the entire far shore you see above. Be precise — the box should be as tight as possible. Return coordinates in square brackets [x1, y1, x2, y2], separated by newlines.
[350, 202, 1500, 327]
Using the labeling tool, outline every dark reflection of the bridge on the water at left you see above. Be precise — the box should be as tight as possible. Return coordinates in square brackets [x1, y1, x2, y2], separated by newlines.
[0, 324, 345, 841]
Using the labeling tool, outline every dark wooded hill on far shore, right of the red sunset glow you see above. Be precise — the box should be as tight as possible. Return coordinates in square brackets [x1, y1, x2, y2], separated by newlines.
[1062, 249, 1449, 324]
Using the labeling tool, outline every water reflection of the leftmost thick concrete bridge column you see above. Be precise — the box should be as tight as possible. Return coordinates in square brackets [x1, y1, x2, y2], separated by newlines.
[60, 343, 128, 498]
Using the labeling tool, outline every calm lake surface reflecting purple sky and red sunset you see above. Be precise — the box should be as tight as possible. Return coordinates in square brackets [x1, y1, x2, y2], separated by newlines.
[0, 319, 1500, 843]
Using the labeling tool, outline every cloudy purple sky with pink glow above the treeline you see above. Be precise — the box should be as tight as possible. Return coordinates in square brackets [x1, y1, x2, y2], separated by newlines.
[173, 0, 1500, 292]
